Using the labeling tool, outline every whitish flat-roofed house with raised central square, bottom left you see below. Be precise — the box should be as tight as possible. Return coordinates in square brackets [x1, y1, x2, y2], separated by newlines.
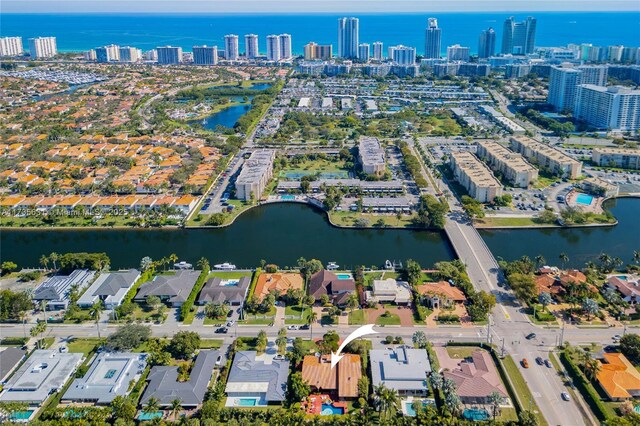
[62, 352, 147, 405]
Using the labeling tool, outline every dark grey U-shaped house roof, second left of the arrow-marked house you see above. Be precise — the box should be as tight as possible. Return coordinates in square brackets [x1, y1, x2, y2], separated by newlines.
[140, 350, 220, 408]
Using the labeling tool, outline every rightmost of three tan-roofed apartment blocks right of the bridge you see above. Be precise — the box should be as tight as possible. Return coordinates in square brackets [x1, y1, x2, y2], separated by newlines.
[510, 136, 582, 179]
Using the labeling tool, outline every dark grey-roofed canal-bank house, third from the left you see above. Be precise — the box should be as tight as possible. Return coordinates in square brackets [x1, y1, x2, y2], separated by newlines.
[134, 270, 200, 308]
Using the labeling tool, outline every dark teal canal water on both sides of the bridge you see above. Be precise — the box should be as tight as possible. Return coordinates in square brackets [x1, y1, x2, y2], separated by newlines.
[0, 199, 640, 268]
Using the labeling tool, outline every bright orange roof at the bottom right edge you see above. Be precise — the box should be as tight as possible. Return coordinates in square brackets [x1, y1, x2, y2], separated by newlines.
[596, 353, 640, 399]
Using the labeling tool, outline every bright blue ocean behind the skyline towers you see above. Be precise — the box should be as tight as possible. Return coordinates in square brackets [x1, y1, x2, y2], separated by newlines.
[0, 11, 640, 54]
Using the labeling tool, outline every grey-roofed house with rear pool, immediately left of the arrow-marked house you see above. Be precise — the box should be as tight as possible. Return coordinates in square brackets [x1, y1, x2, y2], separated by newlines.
[225, 351, 289, 407]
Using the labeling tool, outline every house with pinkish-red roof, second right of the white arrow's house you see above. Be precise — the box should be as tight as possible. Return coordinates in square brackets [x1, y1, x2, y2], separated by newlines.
[443, 350, 508, 404]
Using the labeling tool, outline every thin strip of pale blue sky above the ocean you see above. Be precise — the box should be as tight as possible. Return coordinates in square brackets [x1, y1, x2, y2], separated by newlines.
[1, 0, 640, 14]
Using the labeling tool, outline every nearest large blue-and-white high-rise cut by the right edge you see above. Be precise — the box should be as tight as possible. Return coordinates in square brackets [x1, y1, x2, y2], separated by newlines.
[574, 84, 640, 132]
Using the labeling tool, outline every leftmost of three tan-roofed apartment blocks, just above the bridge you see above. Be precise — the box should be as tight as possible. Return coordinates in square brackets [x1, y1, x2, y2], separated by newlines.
[450, 152, 502, 203]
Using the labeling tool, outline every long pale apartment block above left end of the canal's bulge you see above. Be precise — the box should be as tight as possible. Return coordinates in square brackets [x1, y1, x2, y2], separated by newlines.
[236, 149, 276, 201]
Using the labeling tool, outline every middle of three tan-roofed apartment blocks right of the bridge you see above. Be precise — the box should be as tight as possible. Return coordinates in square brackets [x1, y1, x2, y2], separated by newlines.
[477, 141, 538, 188]
